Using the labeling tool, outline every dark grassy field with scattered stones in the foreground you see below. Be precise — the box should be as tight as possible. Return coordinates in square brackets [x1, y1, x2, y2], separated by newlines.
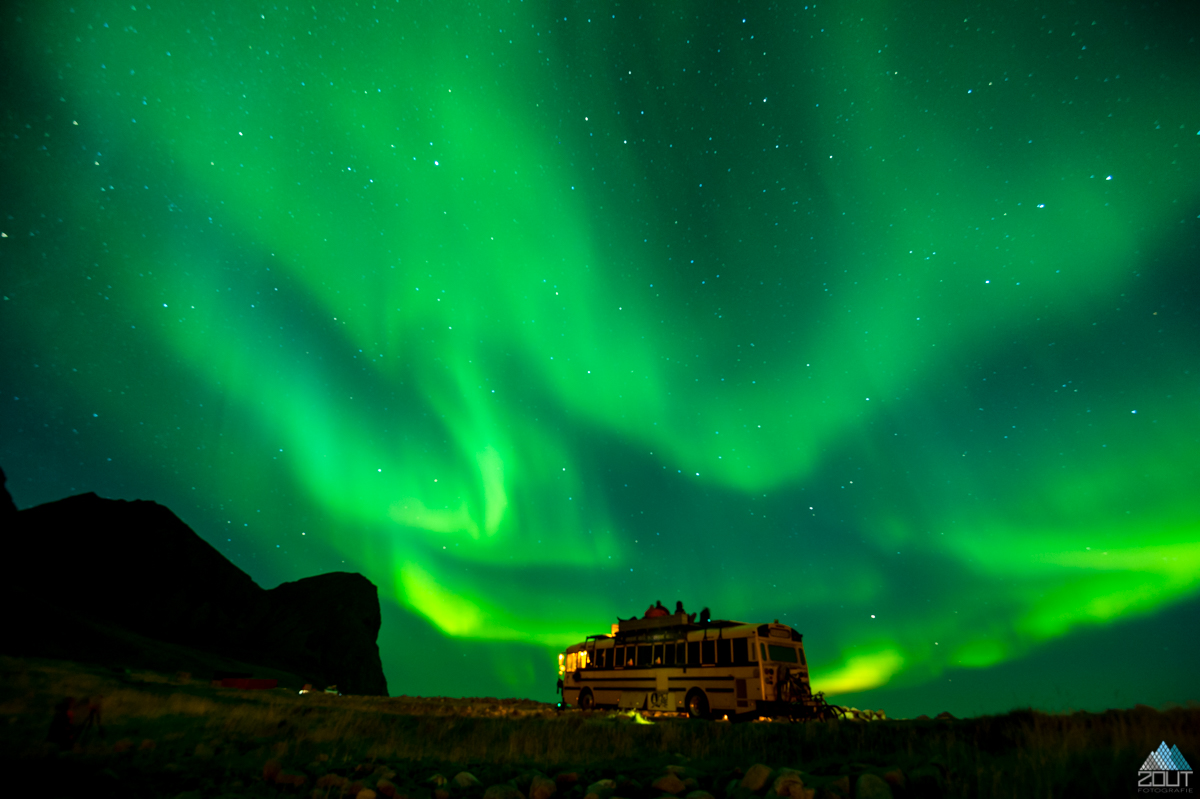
[0, 659, 1200, 799]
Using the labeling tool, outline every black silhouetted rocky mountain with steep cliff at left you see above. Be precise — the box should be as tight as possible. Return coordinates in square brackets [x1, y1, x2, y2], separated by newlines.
[0, 470, 388, 696]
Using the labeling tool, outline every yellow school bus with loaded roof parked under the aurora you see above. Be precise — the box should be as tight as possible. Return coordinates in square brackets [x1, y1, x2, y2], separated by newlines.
[558, 613, 840, 719]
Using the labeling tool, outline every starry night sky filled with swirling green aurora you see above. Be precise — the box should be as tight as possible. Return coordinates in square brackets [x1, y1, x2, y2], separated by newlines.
[0, 0, 1200, 715]
